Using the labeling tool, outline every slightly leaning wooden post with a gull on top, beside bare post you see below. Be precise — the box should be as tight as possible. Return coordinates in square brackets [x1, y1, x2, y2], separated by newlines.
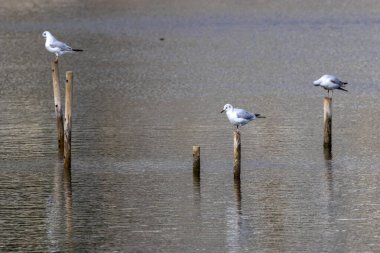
[51, 60, 64, 155]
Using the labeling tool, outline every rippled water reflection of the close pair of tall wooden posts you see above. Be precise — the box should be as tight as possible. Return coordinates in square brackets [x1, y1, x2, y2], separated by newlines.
[47, 161, 75, 252]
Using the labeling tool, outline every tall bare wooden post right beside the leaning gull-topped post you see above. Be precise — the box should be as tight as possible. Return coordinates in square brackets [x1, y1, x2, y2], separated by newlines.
[64, 71, 73, 169]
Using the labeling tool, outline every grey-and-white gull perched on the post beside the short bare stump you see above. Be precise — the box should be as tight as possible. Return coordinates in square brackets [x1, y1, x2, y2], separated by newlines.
[220, 104, 265, 131]
